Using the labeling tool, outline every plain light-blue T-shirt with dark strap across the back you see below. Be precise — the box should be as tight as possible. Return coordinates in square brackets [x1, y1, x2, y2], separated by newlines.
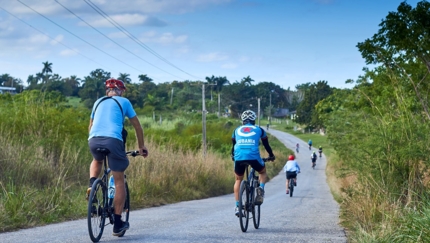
[88, 96, 136, 141]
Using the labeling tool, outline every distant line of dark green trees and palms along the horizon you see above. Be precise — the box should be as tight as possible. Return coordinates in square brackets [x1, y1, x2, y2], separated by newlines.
[0, 61, 333, 126]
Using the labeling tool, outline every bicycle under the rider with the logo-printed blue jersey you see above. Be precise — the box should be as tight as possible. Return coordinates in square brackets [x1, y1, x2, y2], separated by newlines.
[235, 158, 269, 232]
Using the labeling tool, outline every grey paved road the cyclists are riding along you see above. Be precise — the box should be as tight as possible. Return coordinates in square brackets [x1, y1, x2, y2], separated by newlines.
[0, 129, 347, 243]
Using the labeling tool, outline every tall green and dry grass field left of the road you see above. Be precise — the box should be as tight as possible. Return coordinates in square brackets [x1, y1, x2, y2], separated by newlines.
[0, 90, 288, 232]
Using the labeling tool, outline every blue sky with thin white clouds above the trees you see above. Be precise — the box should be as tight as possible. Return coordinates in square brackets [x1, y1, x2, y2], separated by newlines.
[0, 0, 419, 90]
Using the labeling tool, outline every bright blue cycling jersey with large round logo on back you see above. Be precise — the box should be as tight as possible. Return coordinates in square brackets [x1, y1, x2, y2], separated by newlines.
[232, 124, 267, 164]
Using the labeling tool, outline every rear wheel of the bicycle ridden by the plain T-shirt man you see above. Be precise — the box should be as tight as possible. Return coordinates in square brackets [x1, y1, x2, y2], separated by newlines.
[87, 179, 107, 242]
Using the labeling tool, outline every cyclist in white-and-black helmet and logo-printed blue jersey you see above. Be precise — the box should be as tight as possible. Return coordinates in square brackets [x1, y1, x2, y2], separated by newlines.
[231, 110, 275, 216]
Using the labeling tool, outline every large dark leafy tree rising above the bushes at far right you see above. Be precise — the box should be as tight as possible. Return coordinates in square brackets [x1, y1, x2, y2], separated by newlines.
[357, 1, 430, 120]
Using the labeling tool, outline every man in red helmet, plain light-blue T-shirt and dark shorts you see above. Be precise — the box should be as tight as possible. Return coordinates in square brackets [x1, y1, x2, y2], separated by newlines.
[86, 78, 148, 236]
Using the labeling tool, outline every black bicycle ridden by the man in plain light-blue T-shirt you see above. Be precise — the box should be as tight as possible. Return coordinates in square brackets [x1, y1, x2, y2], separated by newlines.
[87, 148, 139, 242]
